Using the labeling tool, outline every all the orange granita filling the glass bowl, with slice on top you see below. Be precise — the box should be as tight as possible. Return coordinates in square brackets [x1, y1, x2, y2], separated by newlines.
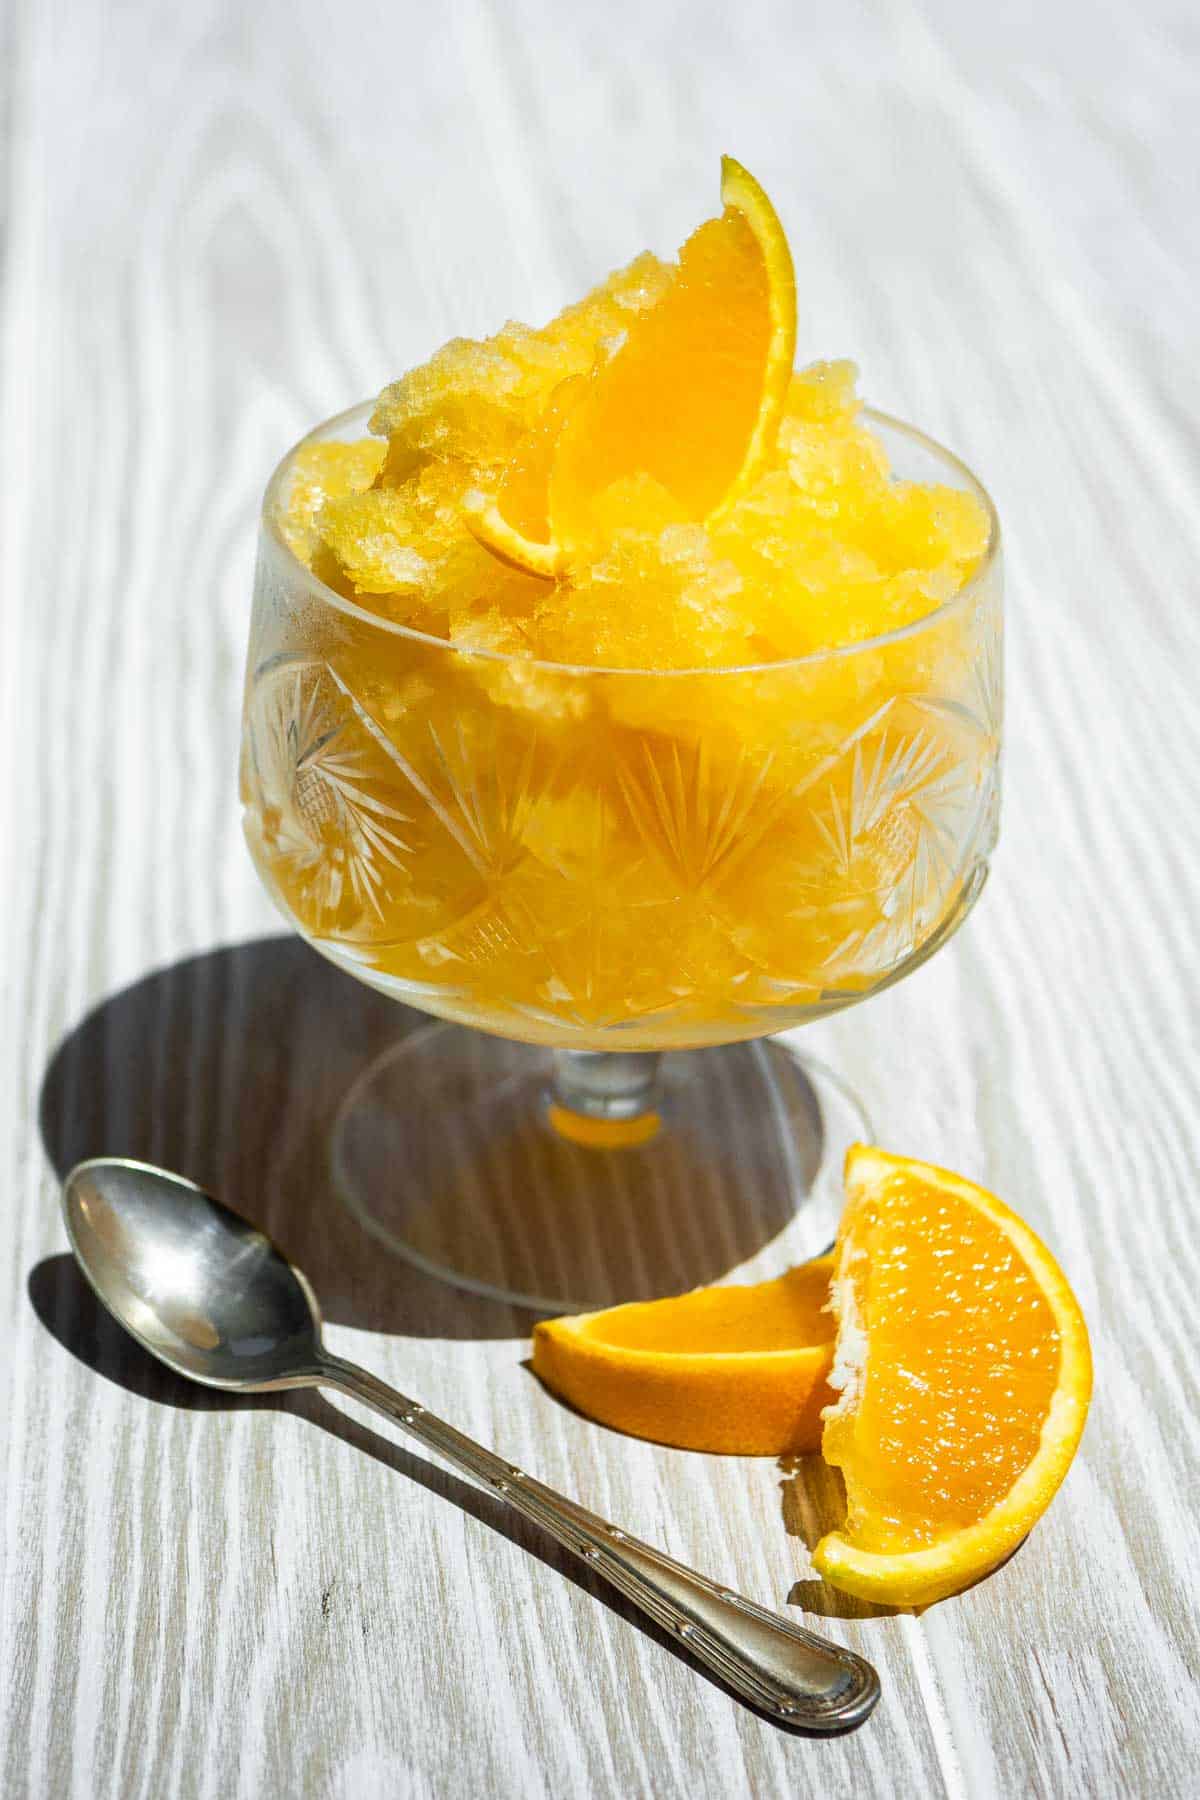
[243, 158, 999, 1048]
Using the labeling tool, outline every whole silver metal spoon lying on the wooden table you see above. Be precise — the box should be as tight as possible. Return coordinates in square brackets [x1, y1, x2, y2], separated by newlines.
[63, 1157, 880, 1732]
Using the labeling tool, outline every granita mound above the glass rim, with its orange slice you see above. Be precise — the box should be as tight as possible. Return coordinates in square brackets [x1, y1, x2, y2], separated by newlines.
[298, 158, 990, 670]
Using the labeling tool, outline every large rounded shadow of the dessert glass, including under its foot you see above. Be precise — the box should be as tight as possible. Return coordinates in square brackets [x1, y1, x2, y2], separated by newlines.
[41, 936, 791, 1337]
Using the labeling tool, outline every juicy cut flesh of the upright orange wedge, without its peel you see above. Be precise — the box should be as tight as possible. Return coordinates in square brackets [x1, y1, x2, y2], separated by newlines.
[822, 1177, 1060, 1552]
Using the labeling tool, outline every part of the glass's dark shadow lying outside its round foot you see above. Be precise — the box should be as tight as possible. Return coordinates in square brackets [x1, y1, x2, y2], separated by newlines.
[40, 936, 529, 1337]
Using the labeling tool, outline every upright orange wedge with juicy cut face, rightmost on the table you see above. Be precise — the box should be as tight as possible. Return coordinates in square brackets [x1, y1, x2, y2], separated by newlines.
[813, 1147, 1092, 1606]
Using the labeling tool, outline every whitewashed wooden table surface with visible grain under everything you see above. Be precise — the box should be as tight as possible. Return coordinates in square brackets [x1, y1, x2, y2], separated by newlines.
[0, 0, 1200, 1800]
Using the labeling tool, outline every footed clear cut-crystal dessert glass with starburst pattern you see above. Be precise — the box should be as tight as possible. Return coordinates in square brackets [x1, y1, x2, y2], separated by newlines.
[241, 405, 1002, 1310]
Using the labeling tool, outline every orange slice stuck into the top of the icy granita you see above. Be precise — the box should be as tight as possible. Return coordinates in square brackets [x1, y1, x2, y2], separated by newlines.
[464, 157, 795, 576]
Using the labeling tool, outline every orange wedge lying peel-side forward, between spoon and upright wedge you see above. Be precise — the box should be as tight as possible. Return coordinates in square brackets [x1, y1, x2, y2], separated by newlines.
[533, 1256, 833, 1456]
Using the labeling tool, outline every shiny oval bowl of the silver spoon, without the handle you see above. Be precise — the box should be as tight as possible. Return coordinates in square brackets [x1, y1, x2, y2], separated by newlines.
[63, 1157, 322, 1393]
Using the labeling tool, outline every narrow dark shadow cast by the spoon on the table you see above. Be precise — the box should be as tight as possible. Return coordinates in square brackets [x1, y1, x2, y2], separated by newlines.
[27, 1255, 874, 1742]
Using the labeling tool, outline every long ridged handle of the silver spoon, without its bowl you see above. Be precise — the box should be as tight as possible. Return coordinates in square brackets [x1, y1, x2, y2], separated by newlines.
[317, 1354, 880, 1732]
